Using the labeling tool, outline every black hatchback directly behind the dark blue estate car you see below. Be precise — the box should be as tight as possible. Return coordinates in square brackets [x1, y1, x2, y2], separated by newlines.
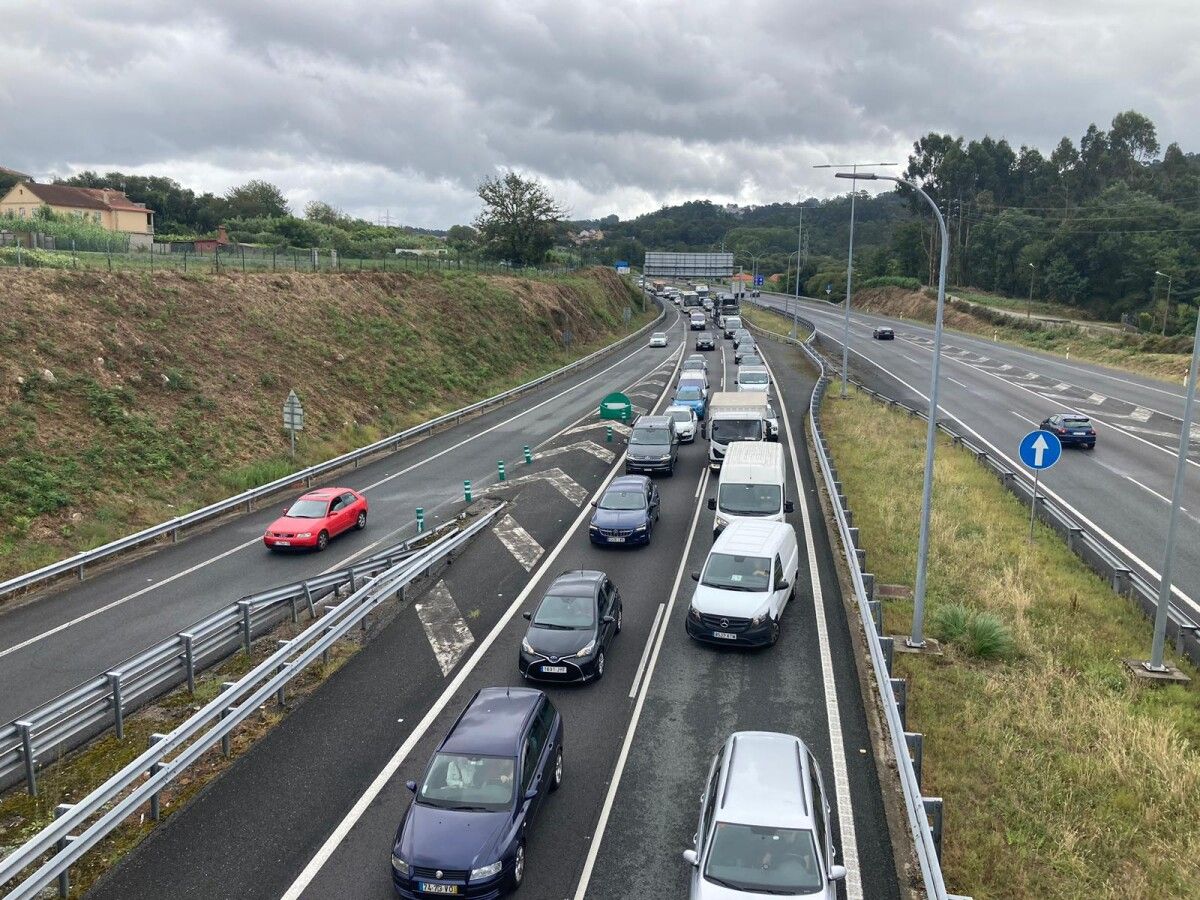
[517, 569, 623, 682]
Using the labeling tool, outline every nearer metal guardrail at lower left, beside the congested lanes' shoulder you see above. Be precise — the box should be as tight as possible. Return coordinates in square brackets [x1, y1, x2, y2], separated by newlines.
[0, 503, 506, 900]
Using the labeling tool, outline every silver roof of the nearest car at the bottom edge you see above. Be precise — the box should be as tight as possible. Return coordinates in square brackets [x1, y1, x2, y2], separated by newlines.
[718, 731, 812, 828]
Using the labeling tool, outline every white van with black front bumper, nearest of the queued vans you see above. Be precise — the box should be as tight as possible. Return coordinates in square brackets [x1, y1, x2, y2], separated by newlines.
[685, 518, 800, 647]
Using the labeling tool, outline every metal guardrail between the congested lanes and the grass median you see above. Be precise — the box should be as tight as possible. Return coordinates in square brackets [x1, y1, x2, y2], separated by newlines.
[751, 317, 955, 900]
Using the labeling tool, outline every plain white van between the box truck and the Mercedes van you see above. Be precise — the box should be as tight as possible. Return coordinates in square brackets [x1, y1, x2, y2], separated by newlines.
[708, 440, 792, 540]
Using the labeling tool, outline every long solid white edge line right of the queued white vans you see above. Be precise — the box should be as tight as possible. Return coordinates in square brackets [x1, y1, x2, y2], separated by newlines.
[763, 359, 863, 900]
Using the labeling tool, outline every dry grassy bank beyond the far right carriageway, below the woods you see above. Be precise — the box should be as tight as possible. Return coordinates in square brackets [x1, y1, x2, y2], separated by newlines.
[853, 288, 1192, 384]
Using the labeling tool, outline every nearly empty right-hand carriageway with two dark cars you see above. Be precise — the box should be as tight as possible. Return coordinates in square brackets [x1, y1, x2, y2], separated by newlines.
[760, 294, 1200, 628]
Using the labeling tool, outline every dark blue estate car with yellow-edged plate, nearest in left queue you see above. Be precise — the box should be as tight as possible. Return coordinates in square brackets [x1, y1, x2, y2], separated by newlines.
[391, 688, 563, 900]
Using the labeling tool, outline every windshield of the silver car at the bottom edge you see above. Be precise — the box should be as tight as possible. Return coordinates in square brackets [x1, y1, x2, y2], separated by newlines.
[704, 822, 822, 894]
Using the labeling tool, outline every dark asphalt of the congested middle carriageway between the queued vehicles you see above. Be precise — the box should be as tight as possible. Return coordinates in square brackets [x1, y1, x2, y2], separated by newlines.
[82, 312, 900, 900]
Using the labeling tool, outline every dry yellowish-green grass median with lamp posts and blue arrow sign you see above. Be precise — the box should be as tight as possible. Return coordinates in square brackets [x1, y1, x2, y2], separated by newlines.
[822, 392, 1200, 900]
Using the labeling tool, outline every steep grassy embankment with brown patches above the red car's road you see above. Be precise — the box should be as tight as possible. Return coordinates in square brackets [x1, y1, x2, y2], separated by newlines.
[0, 269, 654, 577]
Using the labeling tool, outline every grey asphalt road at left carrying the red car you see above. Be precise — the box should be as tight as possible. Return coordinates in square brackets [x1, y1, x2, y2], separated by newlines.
[0, 304, 678, 721]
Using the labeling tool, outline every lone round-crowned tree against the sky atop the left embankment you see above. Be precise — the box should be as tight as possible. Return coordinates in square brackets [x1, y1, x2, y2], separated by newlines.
[475, 172, 566, 265]
